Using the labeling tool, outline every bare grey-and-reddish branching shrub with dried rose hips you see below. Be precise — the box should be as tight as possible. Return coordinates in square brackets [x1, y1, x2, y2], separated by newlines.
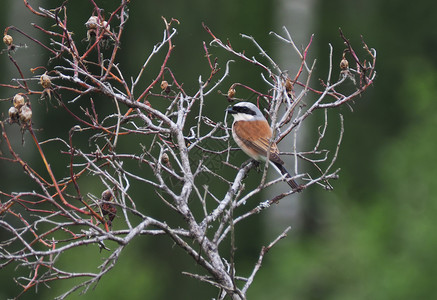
[0, 0, 376, 299]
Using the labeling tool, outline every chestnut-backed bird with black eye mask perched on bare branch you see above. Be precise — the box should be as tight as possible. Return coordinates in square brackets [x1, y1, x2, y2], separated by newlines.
[226, 102, 300, 191]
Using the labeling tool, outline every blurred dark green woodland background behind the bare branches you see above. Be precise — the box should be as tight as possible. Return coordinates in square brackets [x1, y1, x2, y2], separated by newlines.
[0, 0, 437, 300]
